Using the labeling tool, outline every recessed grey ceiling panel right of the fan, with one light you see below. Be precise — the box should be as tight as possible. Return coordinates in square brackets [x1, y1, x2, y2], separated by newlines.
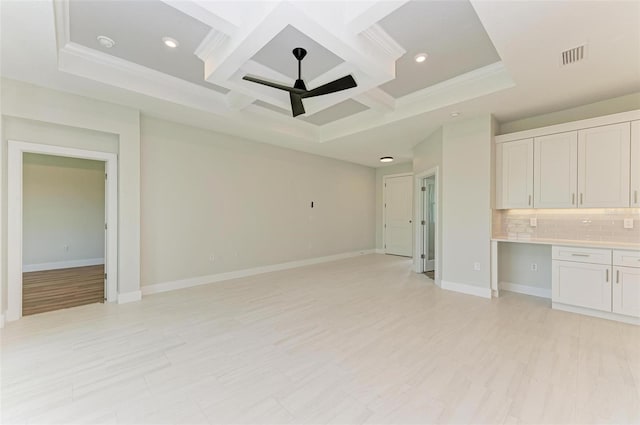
[379, 0, 500, 98]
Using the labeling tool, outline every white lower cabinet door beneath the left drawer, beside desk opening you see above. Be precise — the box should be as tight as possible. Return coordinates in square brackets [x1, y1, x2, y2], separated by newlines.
[551, 261, 612, 311]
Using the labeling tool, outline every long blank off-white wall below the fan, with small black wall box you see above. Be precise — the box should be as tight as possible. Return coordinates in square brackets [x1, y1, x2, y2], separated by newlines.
[141, 117, 376, 285]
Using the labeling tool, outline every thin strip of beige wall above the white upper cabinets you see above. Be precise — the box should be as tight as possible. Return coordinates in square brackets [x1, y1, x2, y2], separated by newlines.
[498, 93, 640, 134]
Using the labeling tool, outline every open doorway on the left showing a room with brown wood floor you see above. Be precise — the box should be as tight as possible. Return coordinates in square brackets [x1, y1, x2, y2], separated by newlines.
[22, 152, 106, 316]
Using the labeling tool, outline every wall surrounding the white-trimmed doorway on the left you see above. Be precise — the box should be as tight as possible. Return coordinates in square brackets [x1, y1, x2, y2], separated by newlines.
[0, 79, 140, 312]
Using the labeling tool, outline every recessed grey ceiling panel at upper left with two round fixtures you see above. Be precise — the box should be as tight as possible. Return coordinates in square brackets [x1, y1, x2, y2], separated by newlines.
[69, 0, 228, 93]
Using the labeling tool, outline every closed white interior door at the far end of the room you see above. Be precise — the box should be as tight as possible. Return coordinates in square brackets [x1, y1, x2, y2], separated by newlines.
[384, 175, 413, 257]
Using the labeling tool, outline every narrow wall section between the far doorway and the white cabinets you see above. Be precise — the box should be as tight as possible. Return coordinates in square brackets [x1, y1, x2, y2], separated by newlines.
[442, 115, 493, 293]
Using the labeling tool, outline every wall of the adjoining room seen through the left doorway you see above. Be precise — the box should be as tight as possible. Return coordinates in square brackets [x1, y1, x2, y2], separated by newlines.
[22, 153, 105, 271]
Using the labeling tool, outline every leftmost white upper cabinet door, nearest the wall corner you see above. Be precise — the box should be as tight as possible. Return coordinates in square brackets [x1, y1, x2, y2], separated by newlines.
[496, 139, 533, 209]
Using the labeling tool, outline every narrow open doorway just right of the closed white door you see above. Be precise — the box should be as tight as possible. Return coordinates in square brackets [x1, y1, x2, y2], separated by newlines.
[414, 167, 441, 283]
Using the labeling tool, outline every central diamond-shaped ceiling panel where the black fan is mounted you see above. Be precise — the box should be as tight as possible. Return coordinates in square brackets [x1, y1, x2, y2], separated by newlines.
[252, 25, 344, 83]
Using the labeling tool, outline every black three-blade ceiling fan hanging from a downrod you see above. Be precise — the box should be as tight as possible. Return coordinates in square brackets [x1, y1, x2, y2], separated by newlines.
[242, 47, 357, 117]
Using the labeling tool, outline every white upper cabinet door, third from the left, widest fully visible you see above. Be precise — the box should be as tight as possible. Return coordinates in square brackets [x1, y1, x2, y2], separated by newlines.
[578, 122, 631, 207]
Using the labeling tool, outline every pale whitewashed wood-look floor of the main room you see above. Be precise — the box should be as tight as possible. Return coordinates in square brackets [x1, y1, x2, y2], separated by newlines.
[1, 255, 640, 424]
